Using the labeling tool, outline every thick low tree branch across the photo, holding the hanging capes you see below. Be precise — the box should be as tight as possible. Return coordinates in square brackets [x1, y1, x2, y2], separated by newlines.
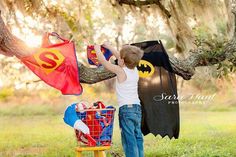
[0, 12, 236, 81]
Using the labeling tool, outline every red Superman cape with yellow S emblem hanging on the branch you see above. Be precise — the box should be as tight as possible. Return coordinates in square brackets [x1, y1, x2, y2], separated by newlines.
[21, 33, 82, 95]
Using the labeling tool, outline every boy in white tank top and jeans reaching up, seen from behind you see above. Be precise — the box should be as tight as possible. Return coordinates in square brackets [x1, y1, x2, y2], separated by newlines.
[94, 42, 144, 157]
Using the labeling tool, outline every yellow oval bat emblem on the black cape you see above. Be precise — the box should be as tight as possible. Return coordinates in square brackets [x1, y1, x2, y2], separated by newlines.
[137, 60, 155, 78]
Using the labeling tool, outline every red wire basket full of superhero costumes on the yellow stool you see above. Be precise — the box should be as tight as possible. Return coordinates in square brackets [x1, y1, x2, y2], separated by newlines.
[75, 108, 115, 146]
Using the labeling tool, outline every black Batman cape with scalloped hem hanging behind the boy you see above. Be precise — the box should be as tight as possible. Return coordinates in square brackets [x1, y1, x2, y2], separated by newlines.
[131, 41, 180, 138]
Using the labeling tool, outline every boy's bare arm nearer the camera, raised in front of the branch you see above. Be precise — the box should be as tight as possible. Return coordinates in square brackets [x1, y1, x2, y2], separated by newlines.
[94, 45, 122, 75]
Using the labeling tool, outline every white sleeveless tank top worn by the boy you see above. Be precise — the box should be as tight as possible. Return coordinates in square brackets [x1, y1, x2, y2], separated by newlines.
[116, 67, 140, 107]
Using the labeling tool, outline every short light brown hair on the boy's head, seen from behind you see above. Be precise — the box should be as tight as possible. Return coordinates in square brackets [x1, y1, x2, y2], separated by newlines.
[120, 45, 143, 69]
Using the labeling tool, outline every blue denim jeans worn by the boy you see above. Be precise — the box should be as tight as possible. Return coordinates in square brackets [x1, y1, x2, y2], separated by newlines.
[119, 104, 144, 157]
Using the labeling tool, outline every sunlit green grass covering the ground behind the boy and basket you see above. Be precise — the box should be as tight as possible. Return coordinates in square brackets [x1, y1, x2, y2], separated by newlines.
[0, 106, 236, 157]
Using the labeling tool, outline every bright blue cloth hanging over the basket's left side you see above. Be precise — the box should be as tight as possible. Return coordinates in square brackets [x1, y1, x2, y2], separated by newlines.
[63, 103, 86, 127]
